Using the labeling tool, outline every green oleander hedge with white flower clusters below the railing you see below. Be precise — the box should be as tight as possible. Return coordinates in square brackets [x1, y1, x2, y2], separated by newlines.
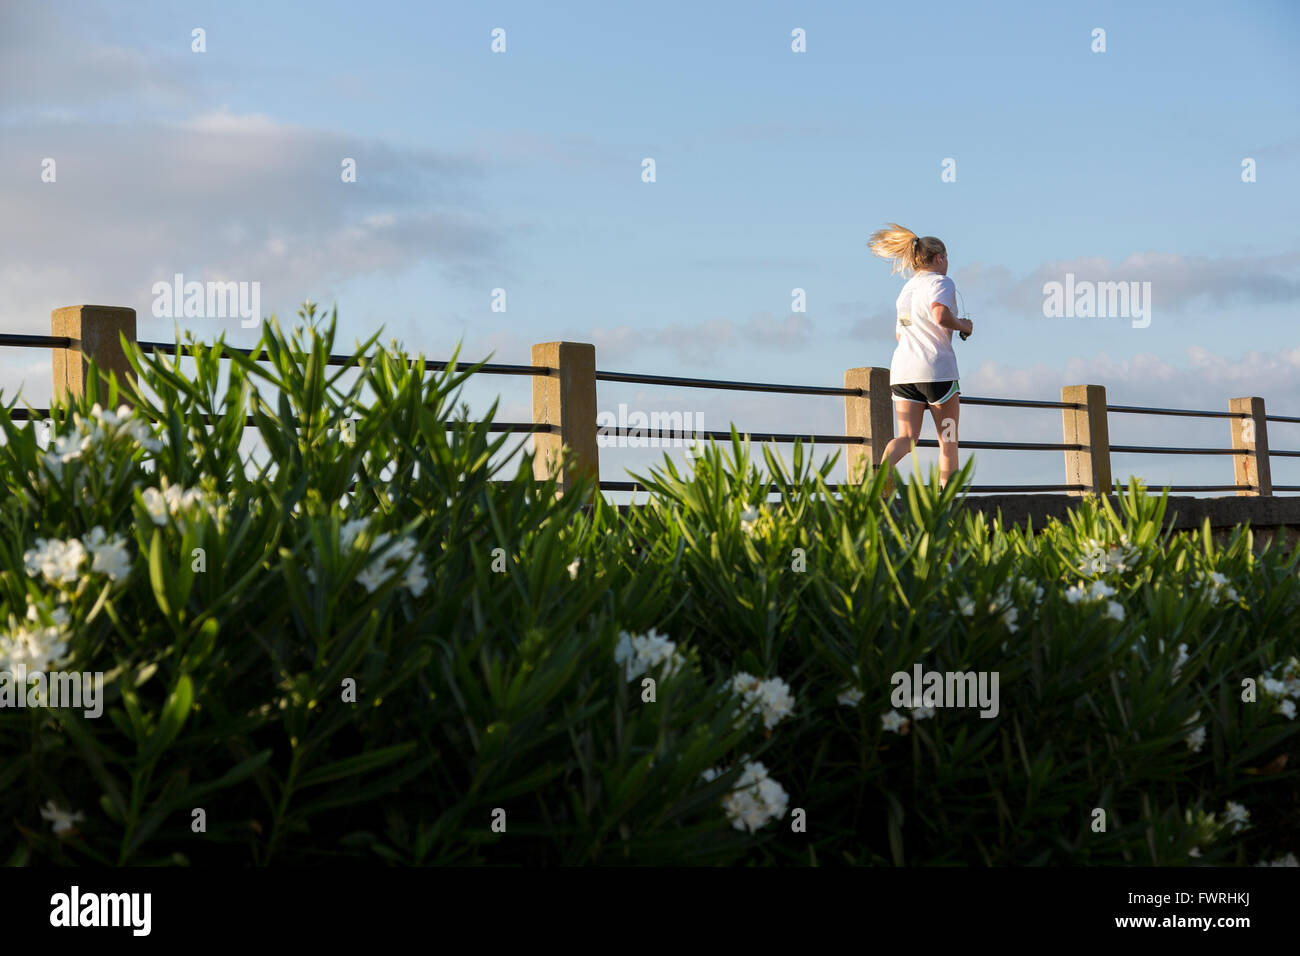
[0, 310, 1300, 866]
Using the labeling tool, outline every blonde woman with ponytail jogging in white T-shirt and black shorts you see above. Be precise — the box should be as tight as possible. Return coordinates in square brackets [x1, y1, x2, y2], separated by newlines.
[868, 222, 975, 493]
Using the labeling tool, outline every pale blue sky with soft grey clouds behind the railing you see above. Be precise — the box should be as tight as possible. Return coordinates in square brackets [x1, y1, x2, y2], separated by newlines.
[0, 0, 1300, 486]
